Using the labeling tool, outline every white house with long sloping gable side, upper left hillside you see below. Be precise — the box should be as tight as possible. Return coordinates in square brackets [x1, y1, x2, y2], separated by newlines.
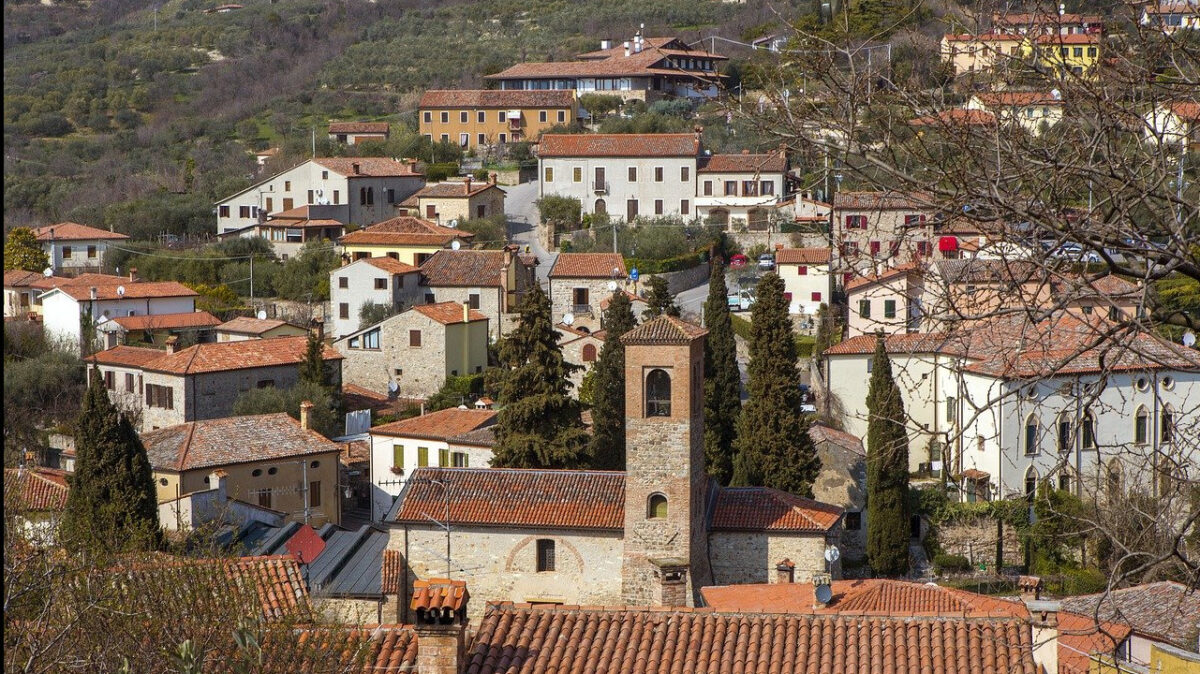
[215, 157, 425, 234]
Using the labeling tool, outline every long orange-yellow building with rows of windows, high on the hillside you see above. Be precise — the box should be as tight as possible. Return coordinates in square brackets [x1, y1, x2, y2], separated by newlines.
[418, 89, 578, 148]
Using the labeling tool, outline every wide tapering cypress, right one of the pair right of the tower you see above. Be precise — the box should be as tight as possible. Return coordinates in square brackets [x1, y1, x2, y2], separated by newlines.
[733, 273, 821, 497]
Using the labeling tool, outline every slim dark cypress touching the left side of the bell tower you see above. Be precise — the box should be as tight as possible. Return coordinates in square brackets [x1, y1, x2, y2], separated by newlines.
[592, 290, 637, 470]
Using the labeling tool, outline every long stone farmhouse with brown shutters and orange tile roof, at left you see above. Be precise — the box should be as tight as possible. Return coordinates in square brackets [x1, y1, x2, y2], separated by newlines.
[88, 336, 342, 432]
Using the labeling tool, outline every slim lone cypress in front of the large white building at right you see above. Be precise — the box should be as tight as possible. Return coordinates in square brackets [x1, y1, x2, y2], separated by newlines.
[866, 335, 908, 576]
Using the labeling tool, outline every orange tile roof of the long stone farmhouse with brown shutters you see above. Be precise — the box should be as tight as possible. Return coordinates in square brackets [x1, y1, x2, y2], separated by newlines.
[143, 335, 342, 374]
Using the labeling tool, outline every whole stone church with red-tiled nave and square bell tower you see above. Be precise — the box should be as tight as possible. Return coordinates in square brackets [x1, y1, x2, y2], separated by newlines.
[385, 317, 842, 622]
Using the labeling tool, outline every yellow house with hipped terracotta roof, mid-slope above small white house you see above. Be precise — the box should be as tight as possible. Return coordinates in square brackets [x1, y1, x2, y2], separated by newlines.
[337, 216, 475, 266]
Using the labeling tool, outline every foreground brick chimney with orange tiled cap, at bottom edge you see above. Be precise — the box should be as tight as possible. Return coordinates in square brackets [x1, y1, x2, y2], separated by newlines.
[409, 578, 470, 674]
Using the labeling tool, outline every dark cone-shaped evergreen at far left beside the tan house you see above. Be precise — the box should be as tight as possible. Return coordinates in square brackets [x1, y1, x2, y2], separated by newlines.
[59, 369, 162, 553]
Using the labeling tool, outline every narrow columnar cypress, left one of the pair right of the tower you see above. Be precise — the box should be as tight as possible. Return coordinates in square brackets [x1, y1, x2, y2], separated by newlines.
[704, 259, 742, 485]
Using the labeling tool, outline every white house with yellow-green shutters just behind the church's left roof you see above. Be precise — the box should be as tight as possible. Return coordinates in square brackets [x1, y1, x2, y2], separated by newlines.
[371, 408, 496, 522]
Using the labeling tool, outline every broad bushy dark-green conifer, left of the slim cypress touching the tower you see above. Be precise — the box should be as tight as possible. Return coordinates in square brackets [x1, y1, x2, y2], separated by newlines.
[492, 285, 590, 468]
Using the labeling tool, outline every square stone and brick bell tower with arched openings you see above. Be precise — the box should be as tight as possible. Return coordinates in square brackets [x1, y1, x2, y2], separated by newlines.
[620, 315, 712, 606]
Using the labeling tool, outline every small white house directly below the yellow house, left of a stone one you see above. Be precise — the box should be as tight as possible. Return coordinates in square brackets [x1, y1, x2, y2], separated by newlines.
[329, 258, 425, 338]
